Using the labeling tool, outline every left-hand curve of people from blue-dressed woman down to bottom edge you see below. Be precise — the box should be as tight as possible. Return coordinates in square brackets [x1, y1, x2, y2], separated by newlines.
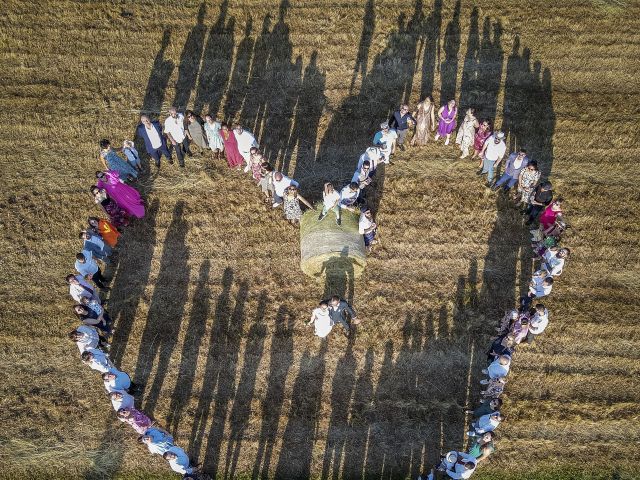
[66, 137, 198, 478]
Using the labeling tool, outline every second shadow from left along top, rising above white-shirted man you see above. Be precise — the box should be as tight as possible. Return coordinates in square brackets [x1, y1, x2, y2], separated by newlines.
[173, 3, 207, 109]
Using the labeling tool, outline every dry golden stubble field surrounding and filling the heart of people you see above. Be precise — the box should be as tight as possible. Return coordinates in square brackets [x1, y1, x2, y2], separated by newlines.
[0, 0, 640, 479]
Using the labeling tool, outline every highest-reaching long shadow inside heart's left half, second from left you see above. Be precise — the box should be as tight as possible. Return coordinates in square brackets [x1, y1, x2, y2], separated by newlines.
[133, 201, 189, 415]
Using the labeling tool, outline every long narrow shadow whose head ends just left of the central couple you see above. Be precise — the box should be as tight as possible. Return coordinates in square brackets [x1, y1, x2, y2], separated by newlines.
[251, 305, 296, 480]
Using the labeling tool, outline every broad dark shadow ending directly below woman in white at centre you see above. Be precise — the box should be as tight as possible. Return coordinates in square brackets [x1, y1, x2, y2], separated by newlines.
[274, 340, 327, 478]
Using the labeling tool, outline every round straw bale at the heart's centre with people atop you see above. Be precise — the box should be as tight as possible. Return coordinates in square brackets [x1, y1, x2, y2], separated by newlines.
[300, 205, 367, 279]
